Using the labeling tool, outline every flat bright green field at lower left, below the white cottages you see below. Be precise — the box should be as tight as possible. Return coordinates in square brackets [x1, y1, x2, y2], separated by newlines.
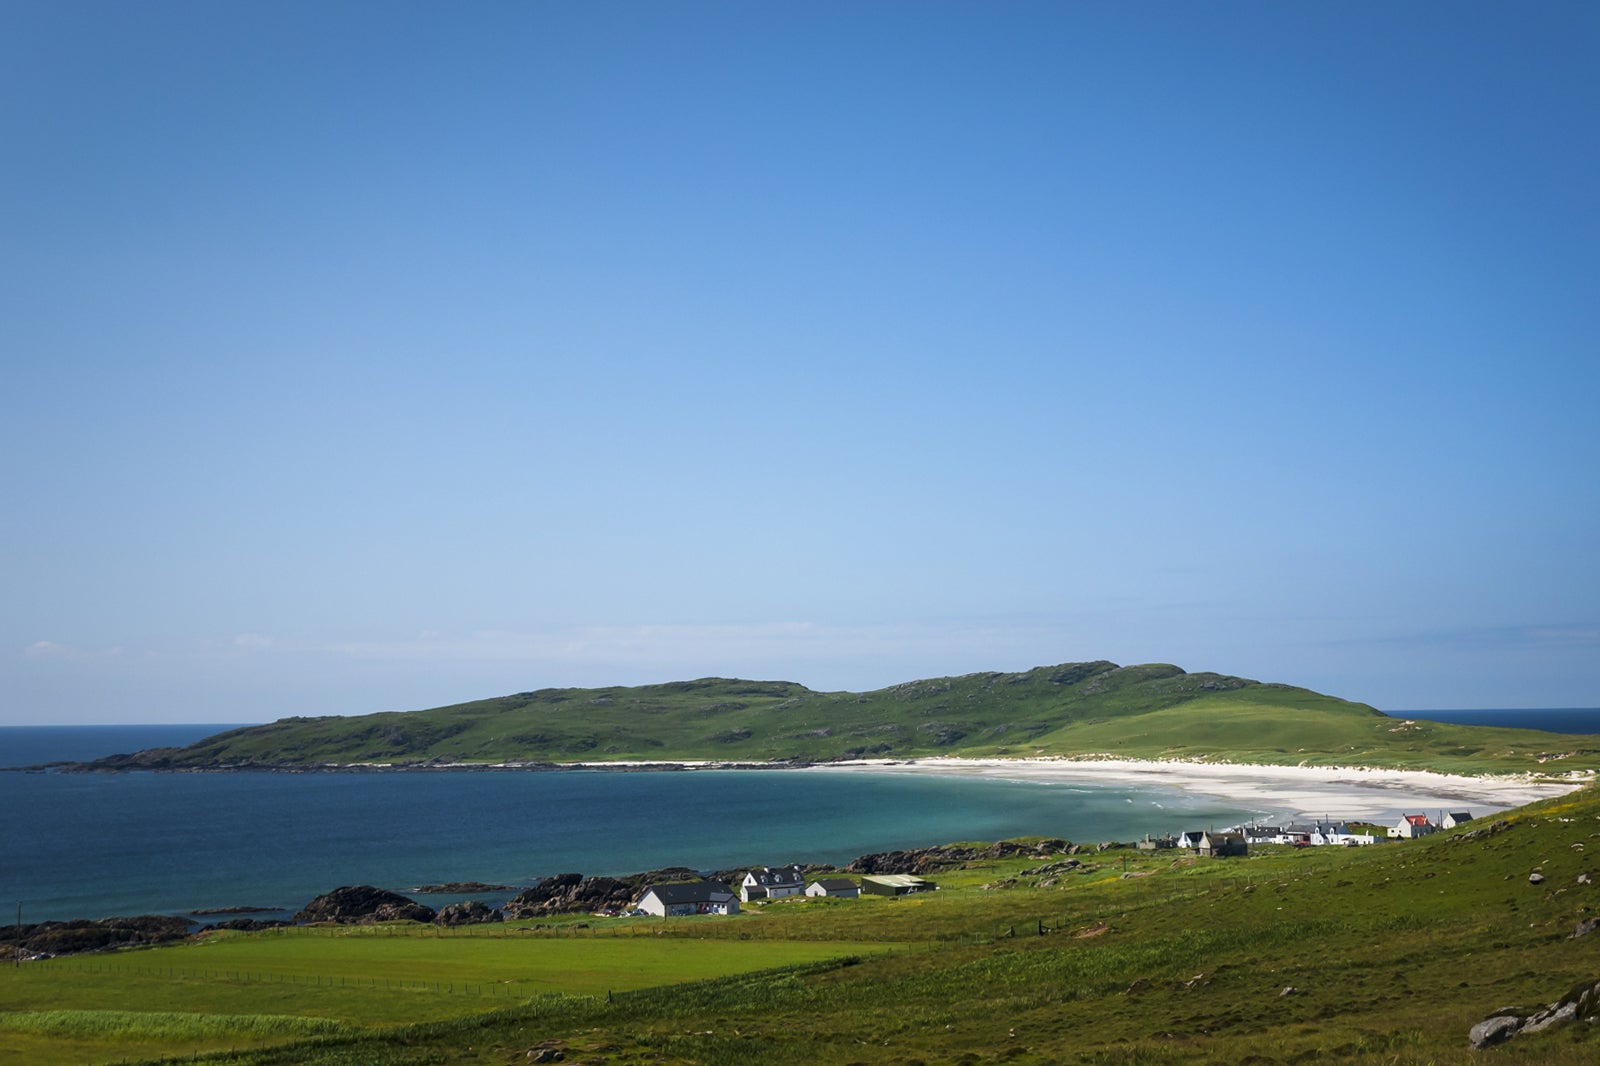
[0, 919, 891, 1066]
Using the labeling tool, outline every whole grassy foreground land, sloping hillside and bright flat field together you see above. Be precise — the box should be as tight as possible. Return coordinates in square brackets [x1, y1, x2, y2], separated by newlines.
[9, 777, 1600, 1066]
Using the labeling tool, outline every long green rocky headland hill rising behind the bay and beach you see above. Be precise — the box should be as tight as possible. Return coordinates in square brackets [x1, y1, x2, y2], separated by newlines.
[96, 661, 1600, 770]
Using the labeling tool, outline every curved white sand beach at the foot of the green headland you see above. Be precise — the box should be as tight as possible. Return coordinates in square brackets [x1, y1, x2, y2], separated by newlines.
[814, 759, 1590, 824]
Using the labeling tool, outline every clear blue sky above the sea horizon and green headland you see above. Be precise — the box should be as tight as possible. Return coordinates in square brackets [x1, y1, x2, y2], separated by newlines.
[0, 0, 1600, 723]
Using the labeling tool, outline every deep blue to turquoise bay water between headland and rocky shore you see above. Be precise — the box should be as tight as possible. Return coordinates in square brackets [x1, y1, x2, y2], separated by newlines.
[0, 727, 1258, 922]
